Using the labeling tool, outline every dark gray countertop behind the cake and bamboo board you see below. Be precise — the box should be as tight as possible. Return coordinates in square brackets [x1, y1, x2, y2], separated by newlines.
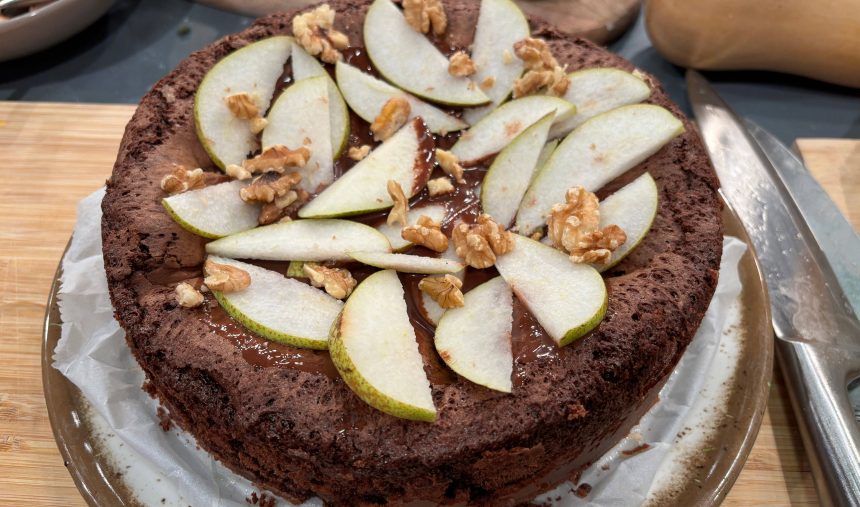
[0, 0, 860, 144]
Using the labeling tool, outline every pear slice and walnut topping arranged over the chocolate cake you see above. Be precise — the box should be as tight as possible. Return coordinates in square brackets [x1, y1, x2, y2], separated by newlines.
[111, 0, 720, 428]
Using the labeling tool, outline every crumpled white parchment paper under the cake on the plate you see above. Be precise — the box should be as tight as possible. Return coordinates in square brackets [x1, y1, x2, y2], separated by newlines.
[54, 189, 745, 507]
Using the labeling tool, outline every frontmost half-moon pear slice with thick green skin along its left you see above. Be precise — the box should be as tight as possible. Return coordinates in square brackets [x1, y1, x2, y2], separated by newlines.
[329, 270, 436, 422]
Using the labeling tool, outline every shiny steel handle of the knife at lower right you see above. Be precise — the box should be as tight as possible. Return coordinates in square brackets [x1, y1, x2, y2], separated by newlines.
[776, 339, 860, 507]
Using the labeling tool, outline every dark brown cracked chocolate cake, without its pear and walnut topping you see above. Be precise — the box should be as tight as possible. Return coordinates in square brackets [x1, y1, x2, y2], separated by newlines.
[102, 0, 722, 505]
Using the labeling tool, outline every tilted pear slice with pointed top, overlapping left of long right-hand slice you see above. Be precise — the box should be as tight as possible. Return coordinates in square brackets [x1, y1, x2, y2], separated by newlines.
[481, 113, 555, 227]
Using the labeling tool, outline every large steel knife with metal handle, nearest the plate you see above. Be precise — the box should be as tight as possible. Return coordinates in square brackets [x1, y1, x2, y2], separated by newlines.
[687, 71, 860, 506]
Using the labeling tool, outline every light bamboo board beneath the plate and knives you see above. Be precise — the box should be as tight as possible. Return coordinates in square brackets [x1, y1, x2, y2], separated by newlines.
[0, 102, 848, 506]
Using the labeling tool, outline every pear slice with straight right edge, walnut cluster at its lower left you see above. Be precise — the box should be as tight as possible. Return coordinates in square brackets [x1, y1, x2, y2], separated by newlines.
[262, 76, 334, 193]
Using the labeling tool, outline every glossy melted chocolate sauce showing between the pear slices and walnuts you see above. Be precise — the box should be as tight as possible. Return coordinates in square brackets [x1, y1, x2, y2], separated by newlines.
[191, 47, 558, 385]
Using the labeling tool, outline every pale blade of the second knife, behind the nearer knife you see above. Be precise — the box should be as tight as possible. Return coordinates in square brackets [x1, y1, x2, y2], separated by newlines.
[744, 120, 860, 315]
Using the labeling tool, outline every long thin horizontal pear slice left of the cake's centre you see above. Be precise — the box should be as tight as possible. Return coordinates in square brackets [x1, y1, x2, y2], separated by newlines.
[206, 220, 391, 262]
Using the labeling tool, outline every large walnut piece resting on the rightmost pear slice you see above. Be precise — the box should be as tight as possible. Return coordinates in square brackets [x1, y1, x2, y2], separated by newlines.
[547, 187, 627, 264]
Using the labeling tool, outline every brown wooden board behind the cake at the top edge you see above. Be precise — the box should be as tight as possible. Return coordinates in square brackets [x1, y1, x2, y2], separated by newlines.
[198, 0, 640, 45]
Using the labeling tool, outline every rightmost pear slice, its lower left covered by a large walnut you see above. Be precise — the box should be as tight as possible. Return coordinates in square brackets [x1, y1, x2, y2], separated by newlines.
[595, 173, 659, 271]
